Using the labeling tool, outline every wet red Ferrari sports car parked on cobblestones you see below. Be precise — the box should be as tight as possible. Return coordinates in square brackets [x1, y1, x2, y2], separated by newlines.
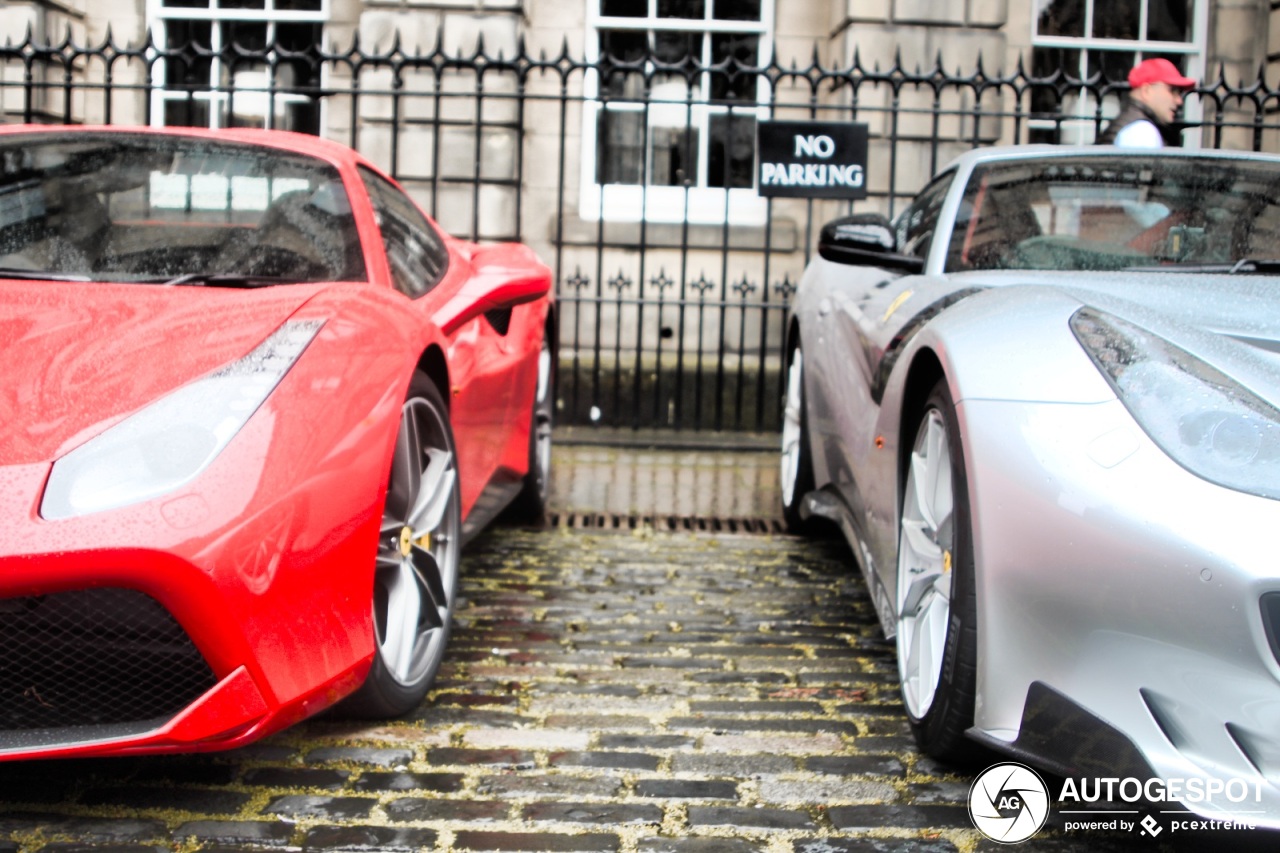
[0, 127, 554, 758]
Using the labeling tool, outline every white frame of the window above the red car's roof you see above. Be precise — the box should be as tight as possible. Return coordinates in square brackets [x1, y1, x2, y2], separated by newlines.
[147, 0, 332, 129]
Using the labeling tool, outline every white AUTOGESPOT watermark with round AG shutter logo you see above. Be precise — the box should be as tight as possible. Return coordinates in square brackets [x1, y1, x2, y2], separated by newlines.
[969, 762, 1262, 844]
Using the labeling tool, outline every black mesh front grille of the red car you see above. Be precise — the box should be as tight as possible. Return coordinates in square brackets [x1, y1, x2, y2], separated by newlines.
[0, 588, 216, 748]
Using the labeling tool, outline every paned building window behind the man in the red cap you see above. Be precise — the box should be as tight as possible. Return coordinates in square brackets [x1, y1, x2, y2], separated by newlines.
[1030, 0, 1208, 143]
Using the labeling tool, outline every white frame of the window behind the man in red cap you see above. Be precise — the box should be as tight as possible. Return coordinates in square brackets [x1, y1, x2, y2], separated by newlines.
[1028, 0, 1208, 149]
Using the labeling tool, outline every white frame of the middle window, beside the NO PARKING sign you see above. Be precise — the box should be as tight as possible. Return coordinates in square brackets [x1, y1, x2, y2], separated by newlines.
[579, 0, 776, 225]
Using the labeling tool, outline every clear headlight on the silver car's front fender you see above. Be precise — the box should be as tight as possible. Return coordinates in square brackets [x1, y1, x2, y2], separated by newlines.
[1071, 309, 1280, 500]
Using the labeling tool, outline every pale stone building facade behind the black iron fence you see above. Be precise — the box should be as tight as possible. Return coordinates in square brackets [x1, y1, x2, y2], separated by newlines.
[0, 0, 1280, 427]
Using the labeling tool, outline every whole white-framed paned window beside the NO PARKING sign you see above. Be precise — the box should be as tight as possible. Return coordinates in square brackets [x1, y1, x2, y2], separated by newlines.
[581, 0, 773, 223]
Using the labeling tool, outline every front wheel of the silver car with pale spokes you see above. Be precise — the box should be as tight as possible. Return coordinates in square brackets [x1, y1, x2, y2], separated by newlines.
[896, 380, 980, 763]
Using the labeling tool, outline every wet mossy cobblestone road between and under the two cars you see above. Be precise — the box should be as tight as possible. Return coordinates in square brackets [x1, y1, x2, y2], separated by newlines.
[0, 448, 1276, 853]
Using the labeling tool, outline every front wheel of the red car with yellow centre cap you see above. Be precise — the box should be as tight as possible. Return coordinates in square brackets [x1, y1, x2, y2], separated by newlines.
[339, 374, 462, 719]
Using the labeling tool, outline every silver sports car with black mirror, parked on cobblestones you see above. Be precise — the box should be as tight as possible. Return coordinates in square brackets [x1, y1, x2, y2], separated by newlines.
[782, 146, 1280, 826]
